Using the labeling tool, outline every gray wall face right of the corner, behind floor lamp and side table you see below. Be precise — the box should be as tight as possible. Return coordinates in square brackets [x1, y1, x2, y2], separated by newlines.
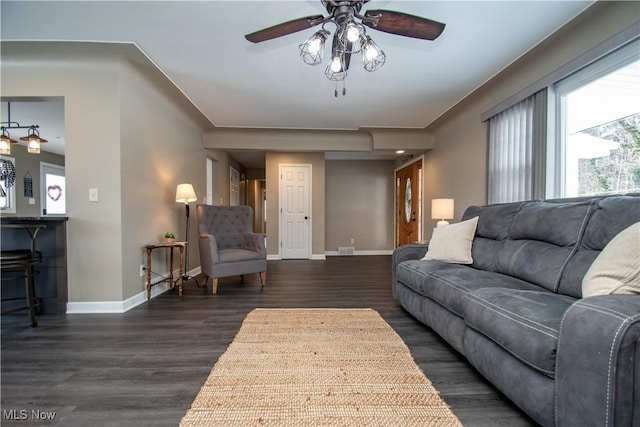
[120, 62, 206, 298]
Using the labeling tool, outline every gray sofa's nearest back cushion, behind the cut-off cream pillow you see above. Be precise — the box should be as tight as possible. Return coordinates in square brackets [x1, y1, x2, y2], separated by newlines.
[558, 195, 640, 298]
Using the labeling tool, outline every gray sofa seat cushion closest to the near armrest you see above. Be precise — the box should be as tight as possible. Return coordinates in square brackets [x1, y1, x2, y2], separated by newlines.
[463, 288, 576, 378]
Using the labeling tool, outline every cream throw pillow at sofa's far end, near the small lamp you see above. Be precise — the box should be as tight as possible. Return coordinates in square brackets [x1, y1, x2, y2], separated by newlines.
[422, 216, 478, 264]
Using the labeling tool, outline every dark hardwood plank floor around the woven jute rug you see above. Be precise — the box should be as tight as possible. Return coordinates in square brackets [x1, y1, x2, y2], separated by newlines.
[0, 256, 535, 427]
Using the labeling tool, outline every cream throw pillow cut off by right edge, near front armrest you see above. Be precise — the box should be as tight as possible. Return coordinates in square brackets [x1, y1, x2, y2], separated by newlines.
[582, 222, 640, 297]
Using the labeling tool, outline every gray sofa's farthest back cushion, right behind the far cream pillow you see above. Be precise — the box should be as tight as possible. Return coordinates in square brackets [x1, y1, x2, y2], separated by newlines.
[462, 202, 527, 271]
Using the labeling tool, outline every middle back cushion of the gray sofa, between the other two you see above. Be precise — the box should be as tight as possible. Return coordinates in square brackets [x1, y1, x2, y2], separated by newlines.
[495, 200, 597, 292]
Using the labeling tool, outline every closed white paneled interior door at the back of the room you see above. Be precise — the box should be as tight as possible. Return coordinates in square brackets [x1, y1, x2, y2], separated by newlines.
[280, 165, 311, 259]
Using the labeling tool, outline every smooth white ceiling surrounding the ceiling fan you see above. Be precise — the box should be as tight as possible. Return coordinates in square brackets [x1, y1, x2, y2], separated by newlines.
[0, 0, 592, 163]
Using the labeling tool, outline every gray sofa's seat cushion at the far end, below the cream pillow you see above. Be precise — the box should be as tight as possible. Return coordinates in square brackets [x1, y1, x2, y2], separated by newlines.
[396, 260, 541, 316]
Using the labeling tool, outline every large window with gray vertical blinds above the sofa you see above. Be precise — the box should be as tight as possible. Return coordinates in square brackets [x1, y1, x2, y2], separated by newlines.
[481, 35, 640, 203]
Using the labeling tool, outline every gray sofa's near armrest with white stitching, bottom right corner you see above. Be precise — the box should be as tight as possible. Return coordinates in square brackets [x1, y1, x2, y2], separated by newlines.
[555, 295, 640, 426]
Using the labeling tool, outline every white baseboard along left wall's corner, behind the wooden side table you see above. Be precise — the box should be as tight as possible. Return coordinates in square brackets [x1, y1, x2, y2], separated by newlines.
[67, 266, 202, 314]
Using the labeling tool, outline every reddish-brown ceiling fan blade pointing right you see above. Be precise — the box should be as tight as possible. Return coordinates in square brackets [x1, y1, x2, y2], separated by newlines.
[362, 10, 445, 40]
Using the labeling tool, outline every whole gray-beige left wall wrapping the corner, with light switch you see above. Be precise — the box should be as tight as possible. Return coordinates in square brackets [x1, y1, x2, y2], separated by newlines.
[1, 43, 205, 309]
